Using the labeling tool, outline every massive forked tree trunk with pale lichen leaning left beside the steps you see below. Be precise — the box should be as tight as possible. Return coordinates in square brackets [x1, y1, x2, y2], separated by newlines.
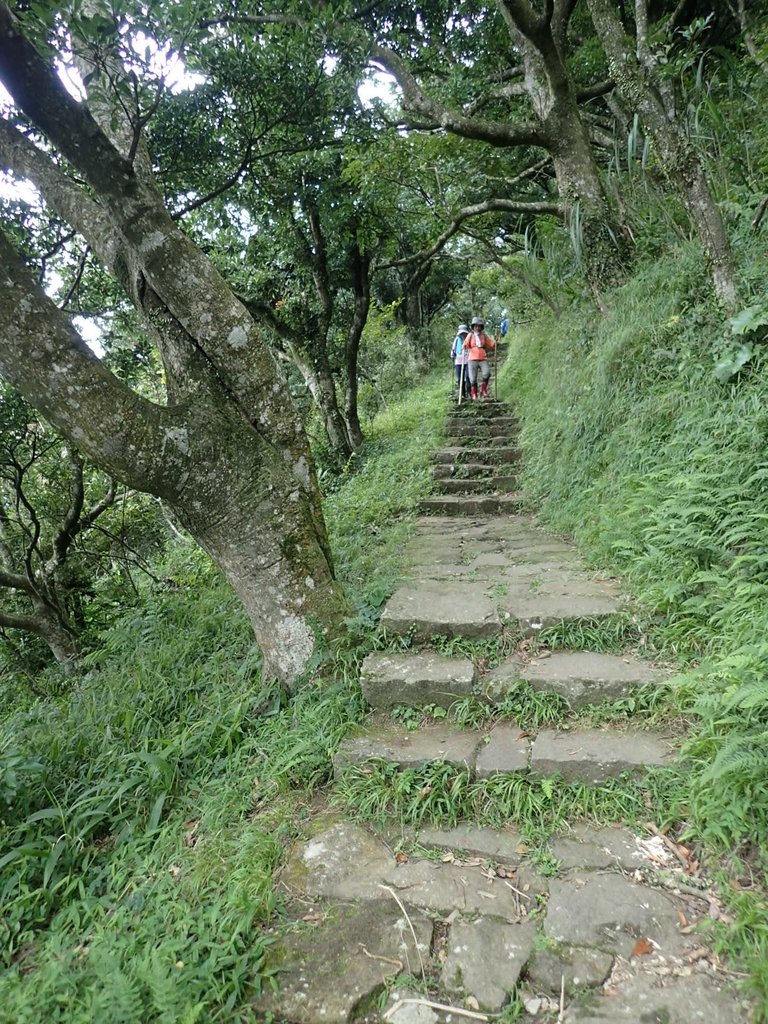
[0, 3, 346, 683]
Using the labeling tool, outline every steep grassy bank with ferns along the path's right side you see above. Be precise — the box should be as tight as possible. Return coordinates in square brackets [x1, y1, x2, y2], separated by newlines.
[502, 220, 768, 1015]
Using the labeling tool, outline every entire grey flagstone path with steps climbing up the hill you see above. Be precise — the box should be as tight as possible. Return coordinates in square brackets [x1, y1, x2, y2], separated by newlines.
[254, 401, 749, 1024]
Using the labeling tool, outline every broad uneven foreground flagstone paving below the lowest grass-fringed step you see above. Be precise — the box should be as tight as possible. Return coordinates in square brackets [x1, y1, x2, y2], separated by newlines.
[264, 812, 755, 1024]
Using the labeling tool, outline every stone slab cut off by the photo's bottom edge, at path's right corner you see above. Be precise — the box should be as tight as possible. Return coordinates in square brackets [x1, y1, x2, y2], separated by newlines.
[564, 974, 751, 1024]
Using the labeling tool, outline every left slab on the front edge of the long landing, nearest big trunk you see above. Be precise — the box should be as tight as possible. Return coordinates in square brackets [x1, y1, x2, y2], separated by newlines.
[381, 584, 501, 639]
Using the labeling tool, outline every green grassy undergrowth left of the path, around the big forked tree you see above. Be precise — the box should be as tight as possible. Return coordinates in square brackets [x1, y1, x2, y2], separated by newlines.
[0, 383, 445, 1024]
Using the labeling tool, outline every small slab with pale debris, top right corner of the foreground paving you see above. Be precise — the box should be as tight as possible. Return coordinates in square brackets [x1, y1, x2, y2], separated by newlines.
[549, 824, 665, 871]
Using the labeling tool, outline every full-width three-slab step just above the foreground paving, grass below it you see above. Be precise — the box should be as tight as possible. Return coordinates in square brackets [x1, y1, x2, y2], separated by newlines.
[334, 720, 674, 785]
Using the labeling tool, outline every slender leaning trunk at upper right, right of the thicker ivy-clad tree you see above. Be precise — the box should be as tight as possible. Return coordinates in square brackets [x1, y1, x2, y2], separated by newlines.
[588, 0, 738, 313]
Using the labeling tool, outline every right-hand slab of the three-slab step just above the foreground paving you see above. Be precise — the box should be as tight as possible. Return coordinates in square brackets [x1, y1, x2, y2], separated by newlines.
[530, 729, 672, 785]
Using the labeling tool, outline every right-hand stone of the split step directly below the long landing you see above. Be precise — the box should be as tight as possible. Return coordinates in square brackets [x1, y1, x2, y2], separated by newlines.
[482, 650, 668, 709]
